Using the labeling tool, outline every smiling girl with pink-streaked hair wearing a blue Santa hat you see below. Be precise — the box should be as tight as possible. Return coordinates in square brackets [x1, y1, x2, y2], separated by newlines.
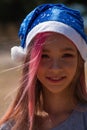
[0, 4, 87, 130]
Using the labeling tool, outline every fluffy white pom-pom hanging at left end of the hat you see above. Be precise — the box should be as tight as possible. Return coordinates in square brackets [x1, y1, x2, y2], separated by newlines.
[11, 46, 26, 62]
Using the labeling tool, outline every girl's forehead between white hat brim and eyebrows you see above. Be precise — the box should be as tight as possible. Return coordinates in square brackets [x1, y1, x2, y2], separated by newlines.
[43, 33, 77, 51]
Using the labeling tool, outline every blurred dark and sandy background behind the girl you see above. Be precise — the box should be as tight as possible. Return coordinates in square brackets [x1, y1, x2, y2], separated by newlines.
[0, 0, 87, 117]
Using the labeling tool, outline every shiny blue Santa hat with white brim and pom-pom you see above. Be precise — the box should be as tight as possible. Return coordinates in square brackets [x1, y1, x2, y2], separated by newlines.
[11, 4, 87, 61]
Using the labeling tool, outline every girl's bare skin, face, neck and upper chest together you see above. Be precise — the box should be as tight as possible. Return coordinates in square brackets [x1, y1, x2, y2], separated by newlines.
[37, 33, 78, 129]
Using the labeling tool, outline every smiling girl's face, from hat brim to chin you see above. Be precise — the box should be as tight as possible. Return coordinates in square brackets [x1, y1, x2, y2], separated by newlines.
[37, 33, 78, 93]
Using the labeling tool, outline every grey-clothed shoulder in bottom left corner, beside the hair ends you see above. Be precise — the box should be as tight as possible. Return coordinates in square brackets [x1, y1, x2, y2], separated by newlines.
[0, 120, 14, 130]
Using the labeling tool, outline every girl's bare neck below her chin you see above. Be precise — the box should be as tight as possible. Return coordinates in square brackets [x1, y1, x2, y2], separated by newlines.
[43, 86, 75, 115]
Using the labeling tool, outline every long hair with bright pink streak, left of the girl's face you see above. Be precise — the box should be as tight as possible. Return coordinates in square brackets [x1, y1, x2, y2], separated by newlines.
[0, 33, 50, 130]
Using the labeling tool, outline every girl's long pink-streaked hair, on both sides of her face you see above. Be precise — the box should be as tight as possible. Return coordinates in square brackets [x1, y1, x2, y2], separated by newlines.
[0, 32, 87, 130]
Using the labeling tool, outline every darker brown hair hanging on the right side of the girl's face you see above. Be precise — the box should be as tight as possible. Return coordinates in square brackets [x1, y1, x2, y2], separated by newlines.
[74, 52, 87, 103]
